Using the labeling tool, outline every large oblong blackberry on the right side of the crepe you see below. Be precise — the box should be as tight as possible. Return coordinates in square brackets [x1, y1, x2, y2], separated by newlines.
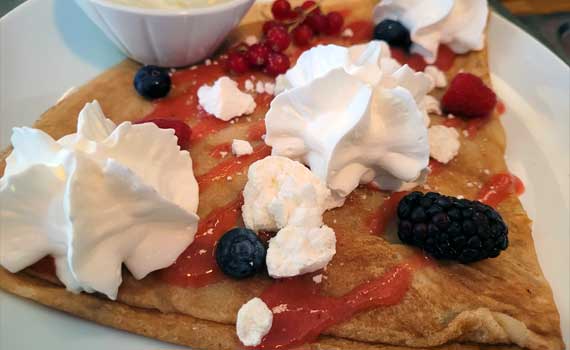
[398, 192, 509, 264]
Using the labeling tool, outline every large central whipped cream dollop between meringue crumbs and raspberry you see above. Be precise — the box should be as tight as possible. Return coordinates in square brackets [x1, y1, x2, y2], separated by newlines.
[265, 41, 433, 200]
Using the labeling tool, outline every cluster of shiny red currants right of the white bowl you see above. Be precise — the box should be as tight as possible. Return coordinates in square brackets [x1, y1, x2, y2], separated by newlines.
[228, 0, 344, 75]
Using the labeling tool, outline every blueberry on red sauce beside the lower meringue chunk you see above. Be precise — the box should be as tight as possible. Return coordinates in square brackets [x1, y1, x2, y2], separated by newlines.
[216, 228, 266, 279]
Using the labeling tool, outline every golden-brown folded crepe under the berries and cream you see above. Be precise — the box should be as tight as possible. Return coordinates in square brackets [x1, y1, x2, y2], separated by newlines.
[0, 0, 564, 350]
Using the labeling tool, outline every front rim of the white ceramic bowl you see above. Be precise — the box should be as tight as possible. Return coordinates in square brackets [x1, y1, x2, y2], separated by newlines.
[84, 0, 255, 16]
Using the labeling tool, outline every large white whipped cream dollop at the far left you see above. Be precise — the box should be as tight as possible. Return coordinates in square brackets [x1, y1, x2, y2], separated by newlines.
[0, 101, 198, 299]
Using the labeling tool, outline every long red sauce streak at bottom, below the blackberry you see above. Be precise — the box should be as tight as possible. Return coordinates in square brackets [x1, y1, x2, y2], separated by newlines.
[249, 255, 432, 350]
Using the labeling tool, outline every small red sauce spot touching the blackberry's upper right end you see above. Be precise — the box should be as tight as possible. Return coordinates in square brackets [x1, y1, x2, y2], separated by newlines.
[477, 173, 525, 207]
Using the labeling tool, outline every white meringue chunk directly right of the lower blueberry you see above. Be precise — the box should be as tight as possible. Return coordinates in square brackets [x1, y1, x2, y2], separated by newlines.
[266, 225, 336, 278]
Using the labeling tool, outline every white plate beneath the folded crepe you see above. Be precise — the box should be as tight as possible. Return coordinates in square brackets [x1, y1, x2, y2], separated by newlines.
[0, 0, 570, 350]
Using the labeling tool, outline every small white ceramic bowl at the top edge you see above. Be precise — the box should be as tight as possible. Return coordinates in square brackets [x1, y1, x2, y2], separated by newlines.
[75, 0, 254, 67]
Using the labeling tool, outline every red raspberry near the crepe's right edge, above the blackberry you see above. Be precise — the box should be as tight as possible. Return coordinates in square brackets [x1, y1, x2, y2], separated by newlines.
[441, 73, 497, 118]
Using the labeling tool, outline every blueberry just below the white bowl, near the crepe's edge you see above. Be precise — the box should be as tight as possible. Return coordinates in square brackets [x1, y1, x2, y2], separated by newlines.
[134, 66, 171, 100]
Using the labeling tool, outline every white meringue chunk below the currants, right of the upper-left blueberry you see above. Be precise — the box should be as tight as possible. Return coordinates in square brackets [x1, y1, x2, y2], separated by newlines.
[198, 77, 256, 121]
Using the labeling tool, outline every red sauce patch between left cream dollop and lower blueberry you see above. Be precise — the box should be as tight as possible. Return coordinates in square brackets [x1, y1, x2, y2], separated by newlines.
[159, 196, 243, 288]
